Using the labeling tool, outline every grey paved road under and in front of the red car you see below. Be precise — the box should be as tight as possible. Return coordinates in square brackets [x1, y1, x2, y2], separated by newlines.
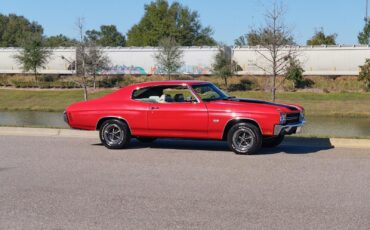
[0, 136, 370, 230]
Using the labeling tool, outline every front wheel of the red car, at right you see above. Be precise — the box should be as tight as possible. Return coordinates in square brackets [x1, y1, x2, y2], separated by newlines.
[227, 123, 262, 155]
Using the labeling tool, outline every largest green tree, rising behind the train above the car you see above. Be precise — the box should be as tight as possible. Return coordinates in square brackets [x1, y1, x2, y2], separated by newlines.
[127, 0, 216, 46]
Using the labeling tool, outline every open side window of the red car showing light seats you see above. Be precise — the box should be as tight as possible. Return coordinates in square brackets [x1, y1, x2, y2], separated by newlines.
[132, 85, 196, 103]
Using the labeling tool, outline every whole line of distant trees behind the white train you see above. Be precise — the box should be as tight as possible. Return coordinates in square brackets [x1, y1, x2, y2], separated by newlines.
[0, 0, 370, 47]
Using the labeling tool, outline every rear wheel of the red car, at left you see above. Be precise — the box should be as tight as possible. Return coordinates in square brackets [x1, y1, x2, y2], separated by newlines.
[99, 119, 131, 149]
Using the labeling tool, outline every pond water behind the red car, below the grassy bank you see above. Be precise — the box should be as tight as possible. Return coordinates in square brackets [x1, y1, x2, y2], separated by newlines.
[0, 111, 370, 137]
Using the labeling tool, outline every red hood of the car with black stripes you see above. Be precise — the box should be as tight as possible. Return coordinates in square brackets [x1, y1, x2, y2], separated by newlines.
[207, 98, 303, 113]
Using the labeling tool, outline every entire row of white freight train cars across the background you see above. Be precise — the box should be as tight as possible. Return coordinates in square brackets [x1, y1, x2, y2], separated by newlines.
[0, 46, 370, 75]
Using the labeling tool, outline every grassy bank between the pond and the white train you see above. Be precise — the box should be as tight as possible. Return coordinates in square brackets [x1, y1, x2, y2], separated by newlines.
[0, 89, 370, 117]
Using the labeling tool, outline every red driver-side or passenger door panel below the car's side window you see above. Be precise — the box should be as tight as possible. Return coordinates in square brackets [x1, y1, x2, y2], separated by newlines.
[148, 85, 208, 138]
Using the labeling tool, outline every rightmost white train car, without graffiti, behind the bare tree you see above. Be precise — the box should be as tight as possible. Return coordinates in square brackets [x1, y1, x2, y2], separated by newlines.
[233, 46, 370, 75]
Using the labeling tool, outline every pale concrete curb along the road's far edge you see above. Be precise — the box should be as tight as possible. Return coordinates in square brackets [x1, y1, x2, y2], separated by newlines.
[0, 127, 370, 149]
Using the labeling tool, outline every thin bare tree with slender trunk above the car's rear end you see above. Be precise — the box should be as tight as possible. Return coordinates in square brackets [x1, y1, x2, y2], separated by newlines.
[76, 18, 88, 101]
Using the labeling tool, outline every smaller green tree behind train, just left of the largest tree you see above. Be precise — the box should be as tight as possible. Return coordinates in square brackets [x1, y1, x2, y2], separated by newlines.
[86, 25, 126, 47]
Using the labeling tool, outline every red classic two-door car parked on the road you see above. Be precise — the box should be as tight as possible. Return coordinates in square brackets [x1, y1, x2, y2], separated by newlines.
[64, 81, 304, 154]
